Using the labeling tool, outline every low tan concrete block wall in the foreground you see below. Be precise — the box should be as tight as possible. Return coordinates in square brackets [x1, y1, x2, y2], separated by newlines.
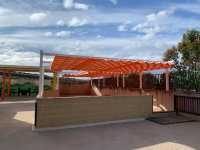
[35, 96, 153, 128]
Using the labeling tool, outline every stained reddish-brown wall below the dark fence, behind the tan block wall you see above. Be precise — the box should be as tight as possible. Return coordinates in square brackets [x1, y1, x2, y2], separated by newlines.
[91, 86, 200, 112]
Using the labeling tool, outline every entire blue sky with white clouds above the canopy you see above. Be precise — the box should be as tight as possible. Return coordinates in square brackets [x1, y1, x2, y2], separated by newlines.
[0, 0, 200, 65]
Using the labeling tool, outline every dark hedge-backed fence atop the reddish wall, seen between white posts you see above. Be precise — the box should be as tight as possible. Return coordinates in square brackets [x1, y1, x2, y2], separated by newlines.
[93, 72, 200, 91]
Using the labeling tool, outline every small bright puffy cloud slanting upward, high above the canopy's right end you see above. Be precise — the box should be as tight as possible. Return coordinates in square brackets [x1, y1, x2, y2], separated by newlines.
[146, 8, 175, 21]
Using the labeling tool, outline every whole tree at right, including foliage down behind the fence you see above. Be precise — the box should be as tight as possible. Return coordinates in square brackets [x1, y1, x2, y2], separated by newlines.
[163, 29, 200, 91]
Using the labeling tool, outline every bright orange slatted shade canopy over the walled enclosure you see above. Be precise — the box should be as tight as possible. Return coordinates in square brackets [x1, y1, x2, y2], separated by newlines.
[51, 55, 174, 78]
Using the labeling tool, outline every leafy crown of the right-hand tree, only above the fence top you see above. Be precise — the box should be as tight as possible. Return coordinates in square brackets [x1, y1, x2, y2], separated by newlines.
[163, 29, 200, 71]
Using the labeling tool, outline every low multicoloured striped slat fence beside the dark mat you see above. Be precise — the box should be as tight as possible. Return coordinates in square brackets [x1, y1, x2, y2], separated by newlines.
[174, 96, 200, 115]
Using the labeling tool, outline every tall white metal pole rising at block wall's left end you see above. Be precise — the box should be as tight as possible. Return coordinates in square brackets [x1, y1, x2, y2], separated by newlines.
[39, 50, 44, 97]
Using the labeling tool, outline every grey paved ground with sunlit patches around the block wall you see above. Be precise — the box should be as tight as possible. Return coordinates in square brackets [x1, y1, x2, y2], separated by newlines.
[0, 97, 200, 150]
